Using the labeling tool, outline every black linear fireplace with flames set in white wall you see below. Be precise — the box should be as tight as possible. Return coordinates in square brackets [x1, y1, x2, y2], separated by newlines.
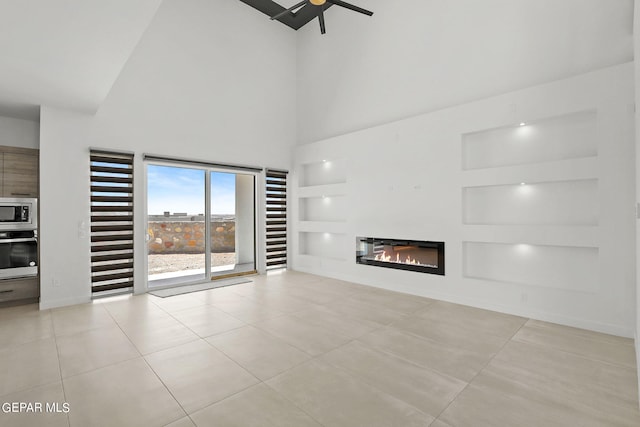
[356, 237, 444, 276]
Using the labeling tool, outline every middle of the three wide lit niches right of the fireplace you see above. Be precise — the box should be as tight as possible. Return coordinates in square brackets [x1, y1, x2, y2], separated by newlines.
[462, 179, 599, 226]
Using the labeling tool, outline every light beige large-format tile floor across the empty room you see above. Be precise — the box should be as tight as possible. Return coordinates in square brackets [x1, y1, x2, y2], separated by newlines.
[0, 272, 640, 427]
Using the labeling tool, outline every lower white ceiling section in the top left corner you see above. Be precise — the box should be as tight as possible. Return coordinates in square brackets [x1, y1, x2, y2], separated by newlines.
[0, 0, 162, 119]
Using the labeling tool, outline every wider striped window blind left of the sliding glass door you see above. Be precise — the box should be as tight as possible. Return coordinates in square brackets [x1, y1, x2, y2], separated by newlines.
[90, 150, 133, 293]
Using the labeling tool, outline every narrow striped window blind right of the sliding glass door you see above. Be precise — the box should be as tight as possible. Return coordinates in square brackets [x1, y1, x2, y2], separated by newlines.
[265, 169, 287, 270]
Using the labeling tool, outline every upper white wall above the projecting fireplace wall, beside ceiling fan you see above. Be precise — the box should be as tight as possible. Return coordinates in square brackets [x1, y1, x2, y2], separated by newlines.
[298, 0, 633, 143]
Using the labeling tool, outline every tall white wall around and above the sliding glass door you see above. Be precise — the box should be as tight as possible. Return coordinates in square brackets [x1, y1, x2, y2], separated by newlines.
[40, 0, 295, 308]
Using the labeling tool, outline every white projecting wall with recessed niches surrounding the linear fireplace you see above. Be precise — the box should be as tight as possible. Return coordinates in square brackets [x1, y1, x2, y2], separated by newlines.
[292, 63, 636, 337]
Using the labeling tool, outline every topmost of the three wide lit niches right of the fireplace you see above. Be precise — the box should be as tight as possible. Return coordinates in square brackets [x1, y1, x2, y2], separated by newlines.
[462, 111, 598, 170]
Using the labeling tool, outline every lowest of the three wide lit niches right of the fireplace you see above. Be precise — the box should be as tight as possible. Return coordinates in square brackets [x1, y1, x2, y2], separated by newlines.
[463, 242, 599, 292]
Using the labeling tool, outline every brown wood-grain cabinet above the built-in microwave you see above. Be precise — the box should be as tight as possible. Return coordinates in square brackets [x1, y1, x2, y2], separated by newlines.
[0, 146, 39, 197]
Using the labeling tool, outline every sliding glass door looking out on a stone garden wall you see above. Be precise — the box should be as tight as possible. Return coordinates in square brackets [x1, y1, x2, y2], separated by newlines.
[147, 163, 256, 287]
